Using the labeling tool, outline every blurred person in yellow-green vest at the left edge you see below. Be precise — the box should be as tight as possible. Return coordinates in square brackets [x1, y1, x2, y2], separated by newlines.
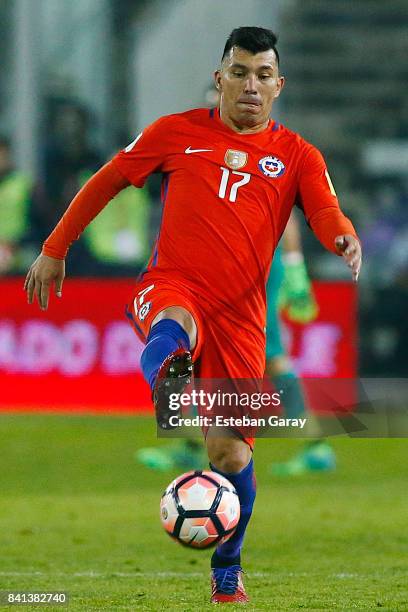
[0, 135, 32, 274]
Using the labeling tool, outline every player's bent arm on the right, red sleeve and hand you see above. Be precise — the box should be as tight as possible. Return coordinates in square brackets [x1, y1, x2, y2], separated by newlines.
[298, 145, 362, 282]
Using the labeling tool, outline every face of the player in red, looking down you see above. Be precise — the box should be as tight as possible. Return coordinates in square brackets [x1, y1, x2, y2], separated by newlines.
[215, 47, 284, 132]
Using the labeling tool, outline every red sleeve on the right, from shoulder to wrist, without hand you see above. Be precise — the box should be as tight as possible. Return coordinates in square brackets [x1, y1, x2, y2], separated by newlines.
[297, 145, 358, 255]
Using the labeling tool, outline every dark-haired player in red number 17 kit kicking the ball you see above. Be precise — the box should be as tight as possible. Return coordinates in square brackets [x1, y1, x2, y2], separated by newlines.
[25, 27, 361, 603]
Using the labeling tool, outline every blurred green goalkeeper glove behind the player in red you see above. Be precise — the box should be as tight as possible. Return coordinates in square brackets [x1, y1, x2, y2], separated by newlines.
[279, 261, 319, 324]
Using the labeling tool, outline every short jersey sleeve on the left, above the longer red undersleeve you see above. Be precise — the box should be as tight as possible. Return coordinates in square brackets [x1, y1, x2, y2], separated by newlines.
[112, 117, 169, 187]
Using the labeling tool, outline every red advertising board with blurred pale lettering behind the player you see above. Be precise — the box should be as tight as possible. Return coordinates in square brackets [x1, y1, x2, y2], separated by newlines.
[0, 278, 357, 413]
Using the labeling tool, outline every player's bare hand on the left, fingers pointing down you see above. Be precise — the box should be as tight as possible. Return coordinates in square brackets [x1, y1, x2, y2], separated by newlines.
[24, 254, 65, 310]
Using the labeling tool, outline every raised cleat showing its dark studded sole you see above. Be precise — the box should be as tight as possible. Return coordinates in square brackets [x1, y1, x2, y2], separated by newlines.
[153, 348, 193, 429]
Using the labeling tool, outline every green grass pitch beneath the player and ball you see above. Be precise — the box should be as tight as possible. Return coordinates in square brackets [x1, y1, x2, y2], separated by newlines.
[0, 414, 408, 612]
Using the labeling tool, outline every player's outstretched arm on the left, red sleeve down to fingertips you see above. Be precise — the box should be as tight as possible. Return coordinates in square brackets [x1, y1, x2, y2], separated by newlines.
[24, 118, 171, 310]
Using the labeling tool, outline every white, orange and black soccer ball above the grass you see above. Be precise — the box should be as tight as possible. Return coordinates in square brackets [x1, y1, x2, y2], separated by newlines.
[160, 470, 240, 548]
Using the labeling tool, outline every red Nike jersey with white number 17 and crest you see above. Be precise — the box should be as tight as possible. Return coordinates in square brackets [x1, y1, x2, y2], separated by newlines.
[113, 109, 355, 334]
